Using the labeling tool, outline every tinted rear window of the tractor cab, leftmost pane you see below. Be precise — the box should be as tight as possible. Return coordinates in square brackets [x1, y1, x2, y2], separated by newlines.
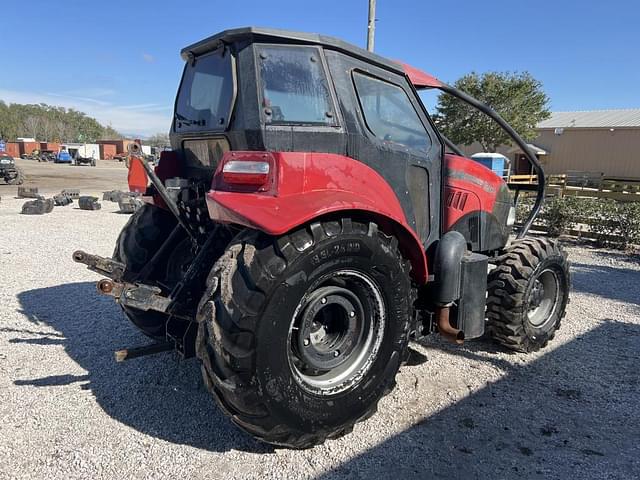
[174, 48, 233, 132]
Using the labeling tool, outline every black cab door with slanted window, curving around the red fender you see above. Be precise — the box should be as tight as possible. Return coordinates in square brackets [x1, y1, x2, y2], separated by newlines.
[326, 51, 442, 248]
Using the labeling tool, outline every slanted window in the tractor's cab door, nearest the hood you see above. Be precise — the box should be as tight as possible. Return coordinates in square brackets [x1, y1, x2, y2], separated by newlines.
[353, 72, 431, 151]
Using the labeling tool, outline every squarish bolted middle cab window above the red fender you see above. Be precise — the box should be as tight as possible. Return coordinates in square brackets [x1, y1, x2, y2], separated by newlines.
[258, 47, 335, 125]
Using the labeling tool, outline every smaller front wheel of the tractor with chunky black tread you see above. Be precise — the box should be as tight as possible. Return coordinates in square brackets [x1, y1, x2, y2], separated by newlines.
[487, 237, 571, 352]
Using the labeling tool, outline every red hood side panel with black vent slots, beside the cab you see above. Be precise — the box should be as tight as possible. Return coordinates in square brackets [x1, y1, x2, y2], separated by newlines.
[442, 154, 503, 231]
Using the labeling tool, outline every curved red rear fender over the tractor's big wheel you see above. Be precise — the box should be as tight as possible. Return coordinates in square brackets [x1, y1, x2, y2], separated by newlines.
[207, 151, 428, 283]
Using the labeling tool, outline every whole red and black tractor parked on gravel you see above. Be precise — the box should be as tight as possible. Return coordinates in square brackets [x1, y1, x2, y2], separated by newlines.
[74, 28, 570, 448]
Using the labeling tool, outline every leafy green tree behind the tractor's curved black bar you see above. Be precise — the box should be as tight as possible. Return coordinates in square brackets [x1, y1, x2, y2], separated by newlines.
[434, 72, 551, 152]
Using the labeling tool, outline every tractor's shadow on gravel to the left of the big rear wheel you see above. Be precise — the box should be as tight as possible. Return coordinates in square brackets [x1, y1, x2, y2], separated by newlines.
[10, 282, 273, 453]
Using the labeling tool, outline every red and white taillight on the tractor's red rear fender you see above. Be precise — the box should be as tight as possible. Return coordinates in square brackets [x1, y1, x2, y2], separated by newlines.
[213, 152, 276, 192]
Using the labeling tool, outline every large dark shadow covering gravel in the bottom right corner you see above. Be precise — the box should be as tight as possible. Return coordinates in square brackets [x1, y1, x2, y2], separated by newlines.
[319, 319, 640, 480]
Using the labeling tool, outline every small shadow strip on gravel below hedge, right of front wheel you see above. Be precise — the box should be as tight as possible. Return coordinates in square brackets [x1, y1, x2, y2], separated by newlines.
[571, 263, 640, 305]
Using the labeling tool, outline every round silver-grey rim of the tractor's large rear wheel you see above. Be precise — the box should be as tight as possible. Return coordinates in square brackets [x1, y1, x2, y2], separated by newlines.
[287, 270, 386, 395]
